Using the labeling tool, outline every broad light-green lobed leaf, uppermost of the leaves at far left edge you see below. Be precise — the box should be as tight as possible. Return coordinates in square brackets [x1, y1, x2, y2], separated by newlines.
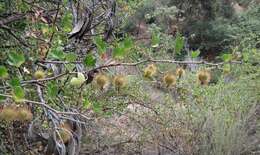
[7, 52, 25, 67]
